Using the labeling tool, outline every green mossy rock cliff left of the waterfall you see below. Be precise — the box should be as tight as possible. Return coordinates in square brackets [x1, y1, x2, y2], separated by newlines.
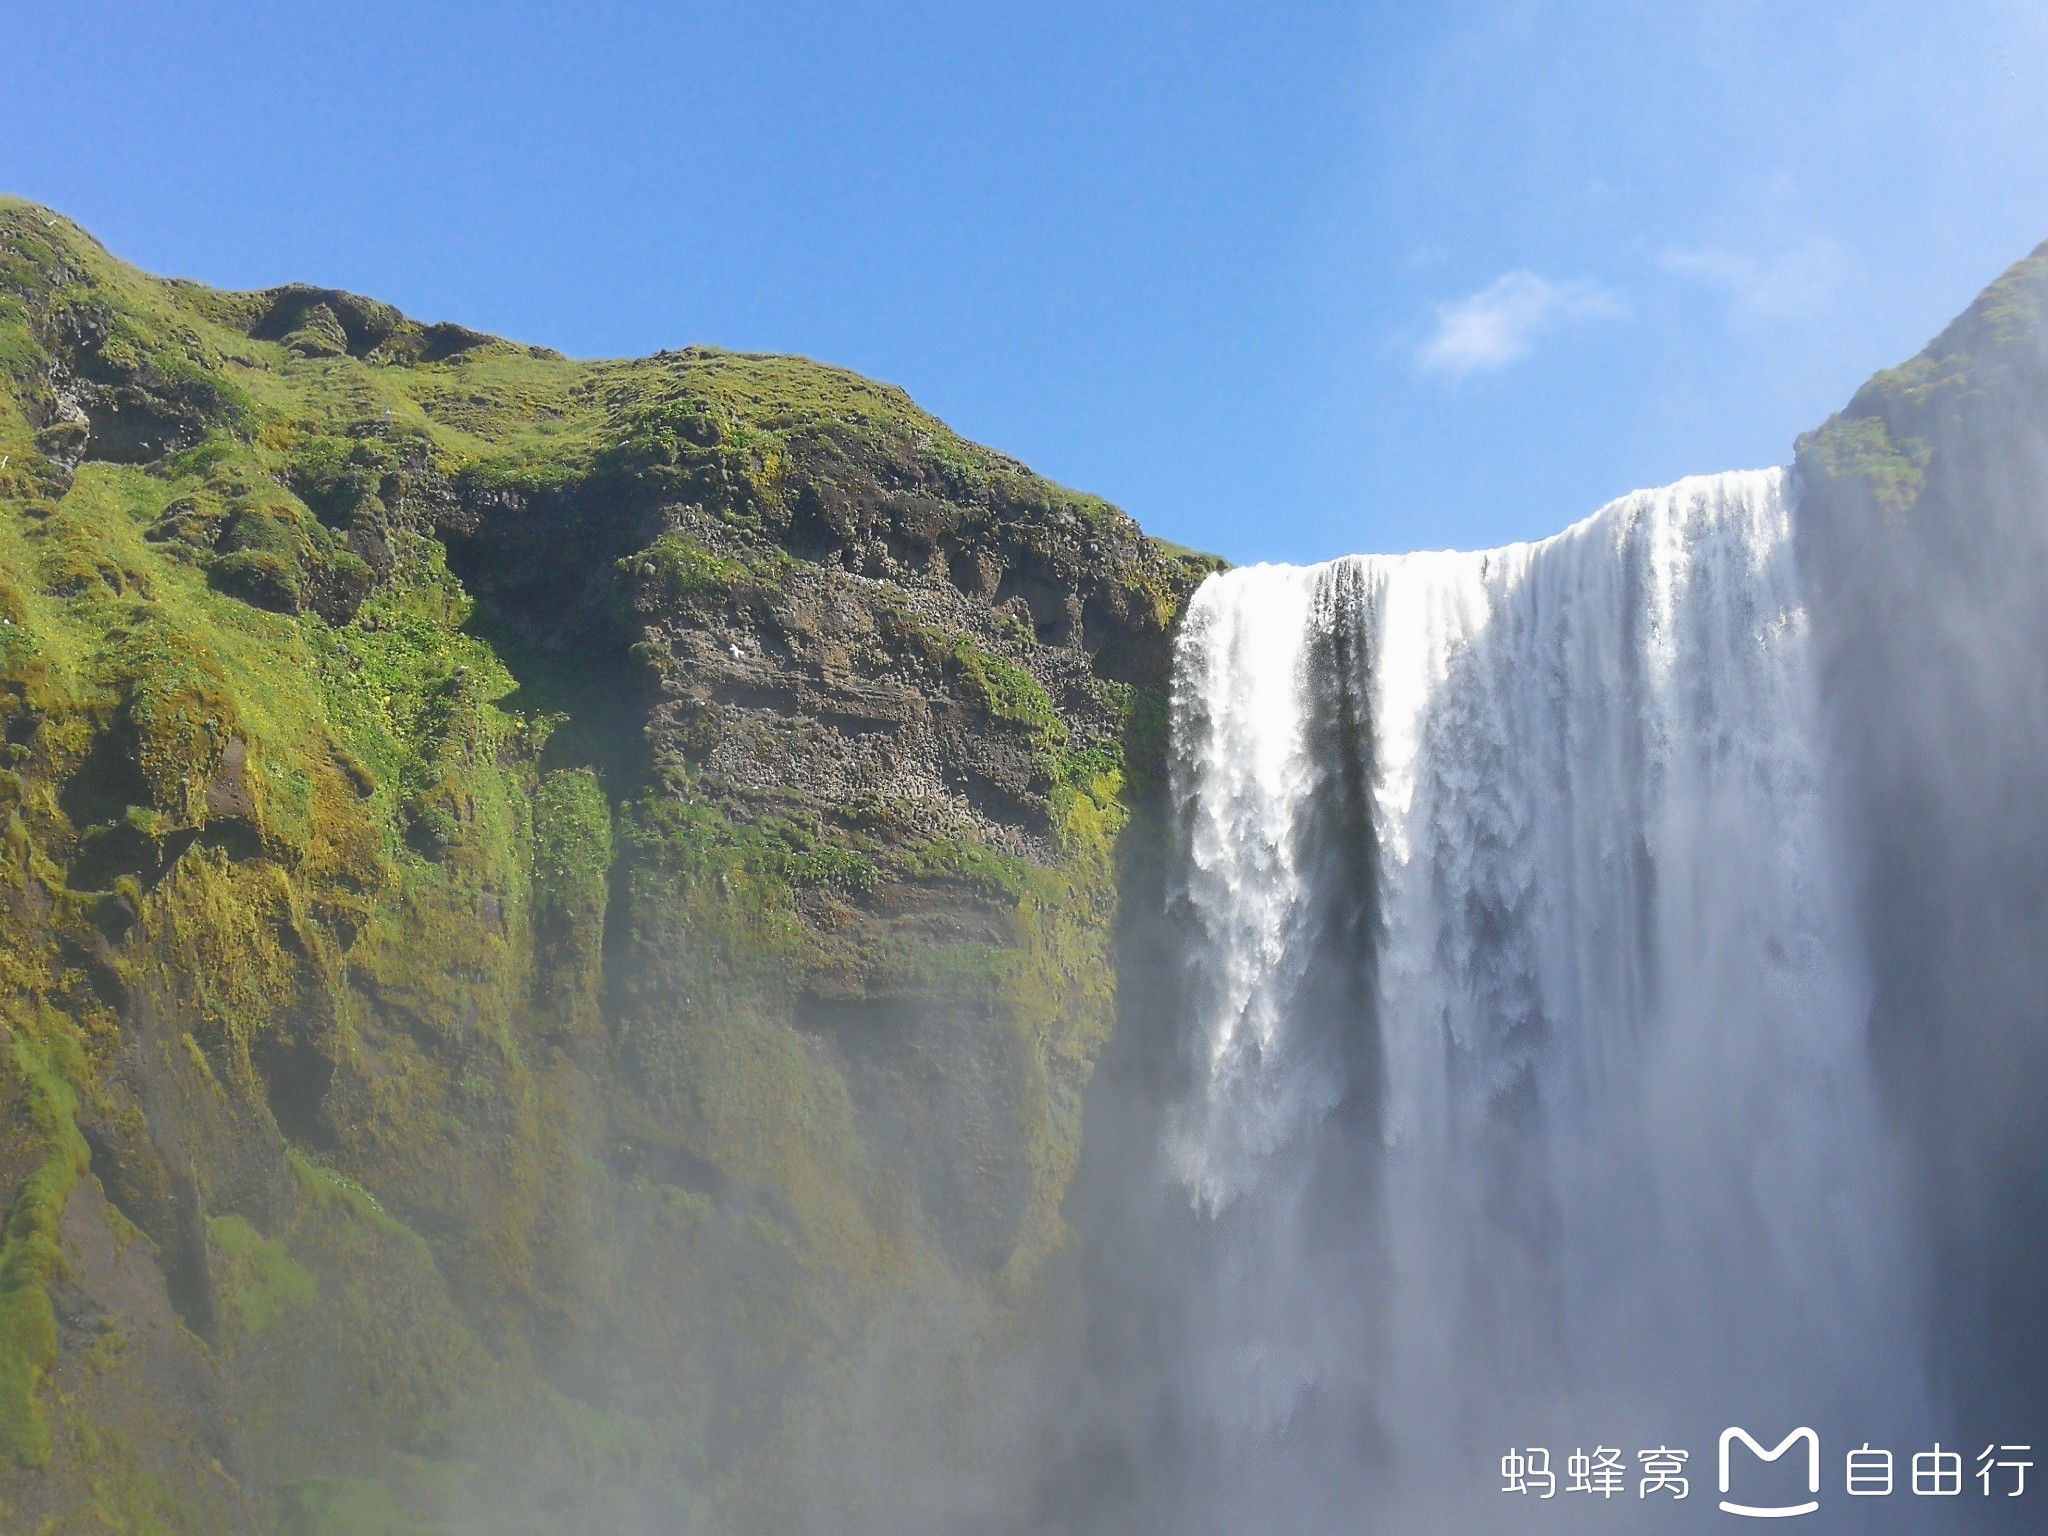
[0, 201, 1204, 1532]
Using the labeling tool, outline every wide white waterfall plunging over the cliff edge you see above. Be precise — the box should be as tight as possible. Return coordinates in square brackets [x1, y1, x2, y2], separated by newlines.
[1124, 471, 1931, 1536]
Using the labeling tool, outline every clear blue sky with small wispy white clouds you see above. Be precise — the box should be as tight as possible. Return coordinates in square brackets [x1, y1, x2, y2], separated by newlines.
[0, 0, 2048, 561]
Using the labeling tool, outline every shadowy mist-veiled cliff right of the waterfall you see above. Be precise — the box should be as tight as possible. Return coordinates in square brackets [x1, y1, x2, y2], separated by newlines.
[1798, 246, 2048, 1436]
